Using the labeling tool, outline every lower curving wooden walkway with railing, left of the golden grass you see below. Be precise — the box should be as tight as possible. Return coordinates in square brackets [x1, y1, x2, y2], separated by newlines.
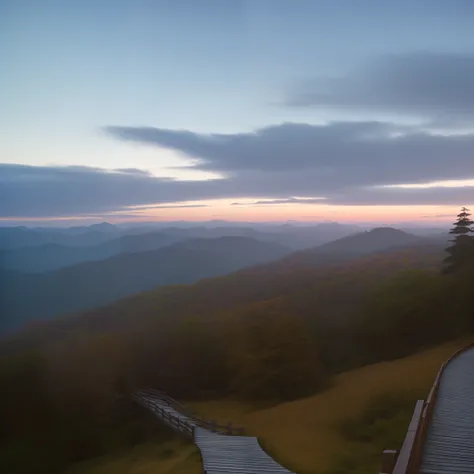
[135, 391, 294, 474]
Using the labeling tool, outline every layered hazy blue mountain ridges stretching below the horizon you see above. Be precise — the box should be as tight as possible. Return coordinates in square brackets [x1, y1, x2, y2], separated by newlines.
[0, 225, 446, 330]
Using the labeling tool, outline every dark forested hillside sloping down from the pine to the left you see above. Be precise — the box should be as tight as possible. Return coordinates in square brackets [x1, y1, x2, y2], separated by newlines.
[0, 211, 474, 473]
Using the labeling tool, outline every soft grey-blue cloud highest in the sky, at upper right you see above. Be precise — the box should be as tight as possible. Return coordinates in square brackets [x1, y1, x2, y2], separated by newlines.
[284, 52, 474, 123]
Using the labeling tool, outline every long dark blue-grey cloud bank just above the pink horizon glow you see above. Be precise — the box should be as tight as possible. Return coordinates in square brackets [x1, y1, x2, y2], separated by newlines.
[0, 122, 474, 217]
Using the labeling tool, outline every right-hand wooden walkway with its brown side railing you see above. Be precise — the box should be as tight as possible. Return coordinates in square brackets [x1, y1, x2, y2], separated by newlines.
[379, 343, 474, 474]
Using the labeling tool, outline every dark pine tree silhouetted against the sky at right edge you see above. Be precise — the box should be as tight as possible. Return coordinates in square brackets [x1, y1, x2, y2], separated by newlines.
[444, 207, 474, 273]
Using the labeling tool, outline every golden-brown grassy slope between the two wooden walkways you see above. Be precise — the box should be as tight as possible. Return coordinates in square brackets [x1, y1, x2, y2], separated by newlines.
[193, 341, 465, 474]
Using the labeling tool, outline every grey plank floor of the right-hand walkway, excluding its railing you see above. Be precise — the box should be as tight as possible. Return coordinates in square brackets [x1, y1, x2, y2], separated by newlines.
[419, 348, 474, 474]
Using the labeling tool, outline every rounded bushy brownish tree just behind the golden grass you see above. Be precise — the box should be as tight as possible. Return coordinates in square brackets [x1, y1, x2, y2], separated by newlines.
[231, 301, 325, 401]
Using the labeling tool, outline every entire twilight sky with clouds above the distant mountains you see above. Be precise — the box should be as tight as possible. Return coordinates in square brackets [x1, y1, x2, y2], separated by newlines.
[0, 0, 474, 225]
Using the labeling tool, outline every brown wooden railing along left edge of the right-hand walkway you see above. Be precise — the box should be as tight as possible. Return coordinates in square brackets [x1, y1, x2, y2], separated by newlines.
[380, 342, 474, 474]
